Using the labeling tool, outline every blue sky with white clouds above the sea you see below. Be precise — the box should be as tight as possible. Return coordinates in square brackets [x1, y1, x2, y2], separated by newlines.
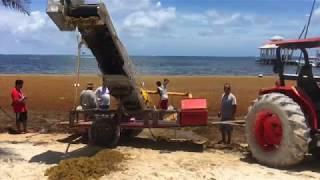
[0, 0, 320, 56]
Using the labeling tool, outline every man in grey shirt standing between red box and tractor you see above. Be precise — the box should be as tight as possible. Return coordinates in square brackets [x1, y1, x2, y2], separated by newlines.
[218, 83, 237, 144]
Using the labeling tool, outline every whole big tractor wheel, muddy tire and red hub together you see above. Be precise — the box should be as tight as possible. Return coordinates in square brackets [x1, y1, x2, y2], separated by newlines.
[246, 93, 310, 167]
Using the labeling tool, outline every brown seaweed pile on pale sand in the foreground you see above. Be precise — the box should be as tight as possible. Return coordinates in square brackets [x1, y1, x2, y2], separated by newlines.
[45, 150, 127, 180]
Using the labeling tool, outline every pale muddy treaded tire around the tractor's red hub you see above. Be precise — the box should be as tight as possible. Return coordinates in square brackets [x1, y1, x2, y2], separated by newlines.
[246, 93, 310, 167]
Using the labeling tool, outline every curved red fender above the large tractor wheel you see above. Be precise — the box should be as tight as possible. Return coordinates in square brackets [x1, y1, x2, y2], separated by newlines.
[259, 86, 318, 130]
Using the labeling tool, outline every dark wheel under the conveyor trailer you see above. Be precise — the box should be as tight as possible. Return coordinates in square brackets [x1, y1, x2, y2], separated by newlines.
[90, 118, 120, 148]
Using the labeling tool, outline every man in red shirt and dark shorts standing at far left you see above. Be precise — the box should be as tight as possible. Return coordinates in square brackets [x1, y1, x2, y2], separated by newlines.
[11, 80, 28, 133]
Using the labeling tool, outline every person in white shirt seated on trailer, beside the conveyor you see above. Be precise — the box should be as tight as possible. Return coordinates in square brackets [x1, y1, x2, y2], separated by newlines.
[95, 78, 111, 110]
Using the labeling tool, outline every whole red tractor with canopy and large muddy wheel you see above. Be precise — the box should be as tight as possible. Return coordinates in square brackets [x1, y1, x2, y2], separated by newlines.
[246, 38, 320, 167]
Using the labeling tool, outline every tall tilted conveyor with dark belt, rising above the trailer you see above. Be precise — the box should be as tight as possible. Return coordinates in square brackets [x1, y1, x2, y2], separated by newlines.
[47, 0, 144, 110]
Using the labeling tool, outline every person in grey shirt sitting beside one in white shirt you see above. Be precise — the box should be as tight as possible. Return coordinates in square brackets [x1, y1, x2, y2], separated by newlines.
[80, 83, 97, 121]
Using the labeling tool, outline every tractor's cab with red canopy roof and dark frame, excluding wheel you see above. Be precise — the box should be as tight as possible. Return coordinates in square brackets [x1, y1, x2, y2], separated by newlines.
[273, 37, 320, 127]
